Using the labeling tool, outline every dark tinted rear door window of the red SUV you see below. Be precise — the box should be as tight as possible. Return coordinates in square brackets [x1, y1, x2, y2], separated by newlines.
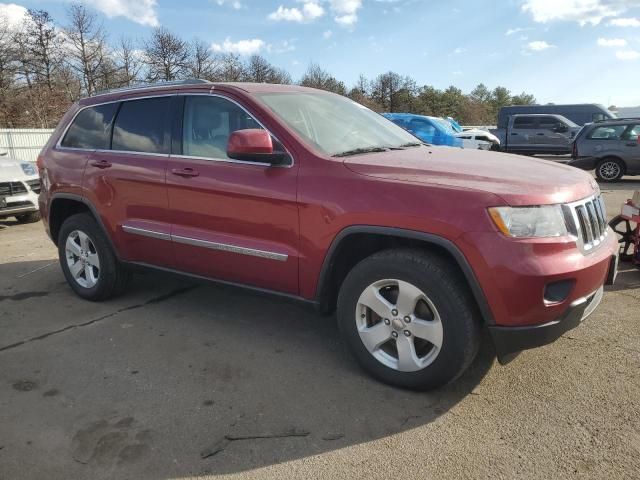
[112, 97, 170, 153]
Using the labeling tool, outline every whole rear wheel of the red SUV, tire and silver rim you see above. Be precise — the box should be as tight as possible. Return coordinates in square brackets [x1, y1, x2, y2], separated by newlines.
[58, 213, 129, 301]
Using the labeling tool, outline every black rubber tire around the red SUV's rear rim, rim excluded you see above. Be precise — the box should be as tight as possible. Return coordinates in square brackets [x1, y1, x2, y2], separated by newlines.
[58, 213, 131, 301]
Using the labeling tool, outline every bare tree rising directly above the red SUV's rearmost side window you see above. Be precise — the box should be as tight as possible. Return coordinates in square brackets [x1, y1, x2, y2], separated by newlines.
[65, 3, 108, 95]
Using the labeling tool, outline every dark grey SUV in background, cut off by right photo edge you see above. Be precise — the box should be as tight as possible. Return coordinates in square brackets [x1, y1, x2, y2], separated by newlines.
[569, 118, 640, 182]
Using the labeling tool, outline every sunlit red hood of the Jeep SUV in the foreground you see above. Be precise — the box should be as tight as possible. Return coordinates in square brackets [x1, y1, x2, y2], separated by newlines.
[344, 146, 599, 206]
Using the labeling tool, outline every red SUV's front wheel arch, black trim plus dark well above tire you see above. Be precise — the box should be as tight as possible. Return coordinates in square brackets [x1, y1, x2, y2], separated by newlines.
[315, 225, 495, 325]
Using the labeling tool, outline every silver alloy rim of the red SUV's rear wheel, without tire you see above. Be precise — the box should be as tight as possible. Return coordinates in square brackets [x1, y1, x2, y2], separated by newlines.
[65, 230, 100, 288]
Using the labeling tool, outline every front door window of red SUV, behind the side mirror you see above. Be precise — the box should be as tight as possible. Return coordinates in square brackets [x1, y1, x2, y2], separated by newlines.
[182, 96, 262, 160]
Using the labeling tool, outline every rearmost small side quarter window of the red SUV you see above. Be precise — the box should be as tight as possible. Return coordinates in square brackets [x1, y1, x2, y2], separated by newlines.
[60, 103, 118, 150]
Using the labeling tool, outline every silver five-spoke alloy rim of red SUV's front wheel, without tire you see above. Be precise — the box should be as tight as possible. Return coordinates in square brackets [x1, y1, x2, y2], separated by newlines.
[355, 279, 444, 372]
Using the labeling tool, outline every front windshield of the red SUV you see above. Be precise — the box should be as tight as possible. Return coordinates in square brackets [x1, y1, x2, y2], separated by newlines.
[256, 92, 420, 156]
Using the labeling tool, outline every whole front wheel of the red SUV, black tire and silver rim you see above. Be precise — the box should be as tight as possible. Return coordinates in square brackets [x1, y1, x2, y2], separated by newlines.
[338, 250, 480, 390]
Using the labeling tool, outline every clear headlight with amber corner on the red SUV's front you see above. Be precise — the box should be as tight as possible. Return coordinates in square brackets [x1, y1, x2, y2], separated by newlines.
[489, 205, 568, 238]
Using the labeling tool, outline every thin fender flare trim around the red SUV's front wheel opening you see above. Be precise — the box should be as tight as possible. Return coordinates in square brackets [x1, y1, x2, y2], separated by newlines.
[315, 225, 495, 325]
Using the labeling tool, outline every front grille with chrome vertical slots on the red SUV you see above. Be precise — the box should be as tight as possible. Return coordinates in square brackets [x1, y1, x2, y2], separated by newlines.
[568, 195, 608, 252]
